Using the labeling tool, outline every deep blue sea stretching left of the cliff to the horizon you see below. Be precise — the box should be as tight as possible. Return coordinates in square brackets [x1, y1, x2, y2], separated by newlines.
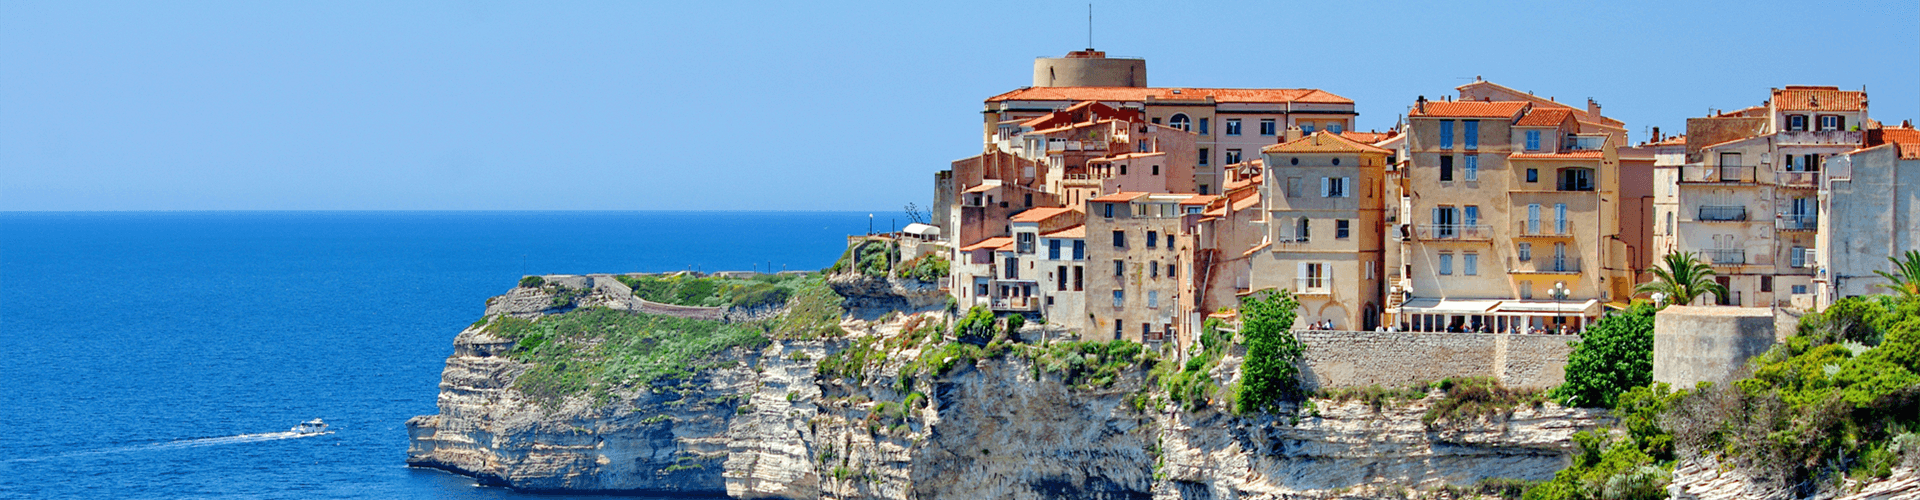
[0, 212, 871, 500]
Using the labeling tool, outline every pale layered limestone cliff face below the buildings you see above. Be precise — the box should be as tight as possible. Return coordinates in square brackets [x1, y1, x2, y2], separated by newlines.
[407, 283, 1599, 498]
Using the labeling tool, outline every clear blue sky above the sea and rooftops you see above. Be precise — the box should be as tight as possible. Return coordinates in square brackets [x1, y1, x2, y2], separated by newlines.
[0, 0, 1920, 212]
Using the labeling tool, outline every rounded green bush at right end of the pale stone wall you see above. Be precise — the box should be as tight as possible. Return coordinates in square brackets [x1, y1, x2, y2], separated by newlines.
[1551, 302, 1655, 408]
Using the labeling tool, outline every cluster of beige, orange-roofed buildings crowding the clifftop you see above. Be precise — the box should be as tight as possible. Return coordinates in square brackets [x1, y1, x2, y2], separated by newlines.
[875, 48, 1920, 346]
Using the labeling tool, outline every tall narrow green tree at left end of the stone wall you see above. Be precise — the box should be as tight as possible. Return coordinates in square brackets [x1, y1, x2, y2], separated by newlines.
[1235, 288, 1304, 413]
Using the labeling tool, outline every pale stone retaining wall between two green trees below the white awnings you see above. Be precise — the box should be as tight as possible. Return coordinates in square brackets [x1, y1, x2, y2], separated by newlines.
[1294, 331, 1578, 388]
